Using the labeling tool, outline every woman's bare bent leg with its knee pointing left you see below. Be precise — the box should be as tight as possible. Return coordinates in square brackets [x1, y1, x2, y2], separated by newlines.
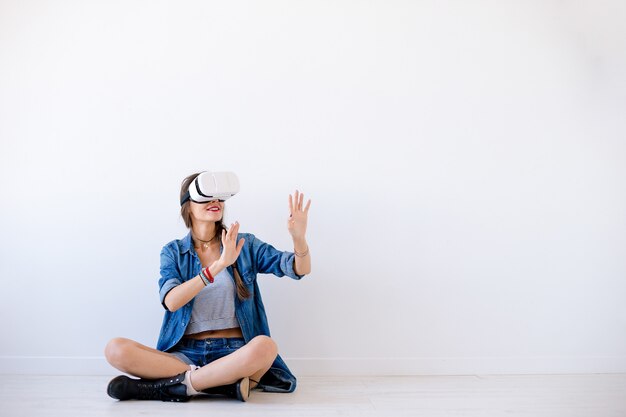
[104, 337, 189, 379]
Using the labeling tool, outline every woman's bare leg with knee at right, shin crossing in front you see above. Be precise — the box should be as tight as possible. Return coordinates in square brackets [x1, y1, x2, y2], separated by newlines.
[186, 336, 278, 391]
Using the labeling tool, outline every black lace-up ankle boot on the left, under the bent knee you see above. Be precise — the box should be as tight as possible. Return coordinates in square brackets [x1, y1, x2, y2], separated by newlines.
[107, 372, 191, 402]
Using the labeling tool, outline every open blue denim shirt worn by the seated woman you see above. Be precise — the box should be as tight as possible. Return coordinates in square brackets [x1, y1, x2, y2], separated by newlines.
[157, 233, 304, 392]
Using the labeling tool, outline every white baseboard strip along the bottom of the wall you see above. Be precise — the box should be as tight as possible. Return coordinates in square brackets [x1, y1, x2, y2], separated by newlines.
[0, 356, 626, 376]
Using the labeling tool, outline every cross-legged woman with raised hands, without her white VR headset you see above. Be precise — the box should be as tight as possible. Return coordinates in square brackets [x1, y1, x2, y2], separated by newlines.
[105, 173, 311, 401]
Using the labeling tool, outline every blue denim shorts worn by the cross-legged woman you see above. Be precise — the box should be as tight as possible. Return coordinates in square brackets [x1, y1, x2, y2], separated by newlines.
[167, 337, 246, 367]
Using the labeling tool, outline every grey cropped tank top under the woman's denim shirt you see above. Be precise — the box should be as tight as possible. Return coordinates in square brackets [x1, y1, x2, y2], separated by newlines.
[185, 268, 239, 335]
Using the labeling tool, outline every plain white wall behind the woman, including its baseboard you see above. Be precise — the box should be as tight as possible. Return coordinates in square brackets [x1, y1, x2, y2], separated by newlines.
[0, 0, 626, 375]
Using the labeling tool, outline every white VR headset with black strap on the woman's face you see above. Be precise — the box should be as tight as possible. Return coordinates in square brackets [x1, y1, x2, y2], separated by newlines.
[180, 171, 239, 206]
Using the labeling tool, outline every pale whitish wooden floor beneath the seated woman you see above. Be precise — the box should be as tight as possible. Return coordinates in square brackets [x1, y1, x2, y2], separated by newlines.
[0, 374, 626, 417]
